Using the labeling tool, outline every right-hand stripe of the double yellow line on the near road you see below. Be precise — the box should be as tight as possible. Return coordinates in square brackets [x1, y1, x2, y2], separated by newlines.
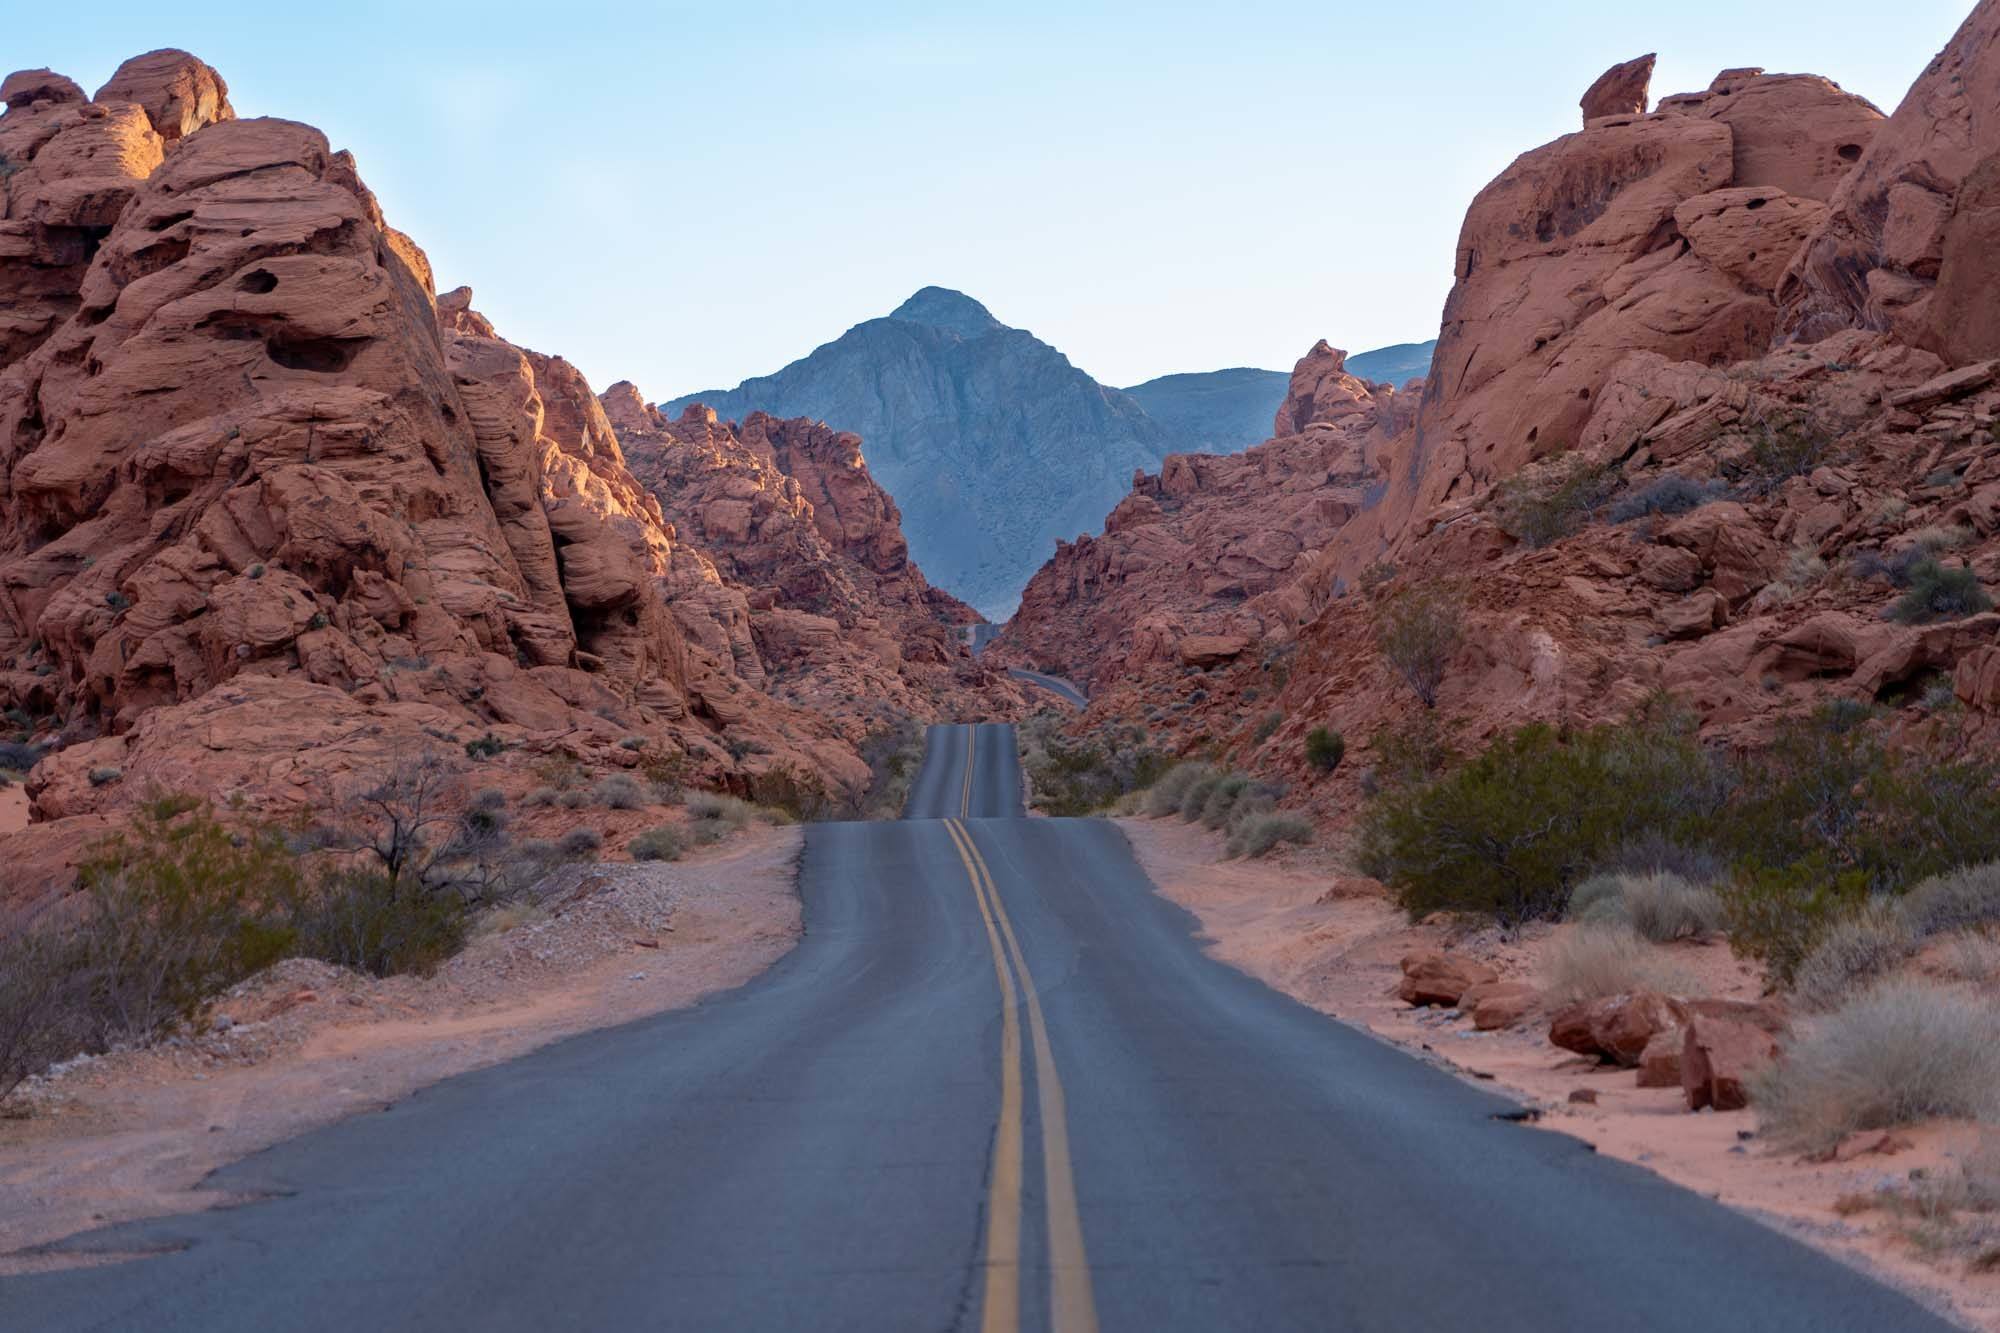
[944, 819, 1098, 1333]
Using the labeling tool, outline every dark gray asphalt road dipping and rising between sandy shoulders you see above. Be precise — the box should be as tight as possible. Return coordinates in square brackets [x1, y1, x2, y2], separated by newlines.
[0, 727, 1946, 1333]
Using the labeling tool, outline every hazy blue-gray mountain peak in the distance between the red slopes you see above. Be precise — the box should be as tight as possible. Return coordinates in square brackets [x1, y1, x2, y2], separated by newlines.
[662, 286, 1176, 618]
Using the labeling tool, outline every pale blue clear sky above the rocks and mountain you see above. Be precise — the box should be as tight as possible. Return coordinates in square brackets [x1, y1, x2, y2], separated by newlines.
[15, 0, 1972, 398]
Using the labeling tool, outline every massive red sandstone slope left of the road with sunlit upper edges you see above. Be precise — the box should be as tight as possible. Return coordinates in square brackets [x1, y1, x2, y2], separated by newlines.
[0, 50, 1000, 893]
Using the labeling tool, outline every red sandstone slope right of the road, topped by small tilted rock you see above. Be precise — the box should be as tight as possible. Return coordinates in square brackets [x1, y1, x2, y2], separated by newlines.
[996, 0, 2000, 805]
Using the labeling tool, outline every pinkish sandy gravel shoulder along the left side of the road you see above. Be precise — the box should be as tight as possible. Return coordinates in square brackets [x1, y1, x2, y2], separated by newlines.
[0, 825, 802, 1275]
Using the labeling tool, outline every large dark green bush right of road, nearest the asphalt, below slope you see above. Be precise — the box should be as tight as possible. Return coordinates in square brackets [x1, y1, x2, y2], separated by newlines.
[1358, 717, 1728, 927]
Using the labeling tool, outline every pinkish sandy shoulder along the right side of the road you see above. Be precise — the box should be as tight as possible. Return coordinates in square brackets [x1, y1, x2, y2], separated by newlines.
[1114, 819, 2000, 1333]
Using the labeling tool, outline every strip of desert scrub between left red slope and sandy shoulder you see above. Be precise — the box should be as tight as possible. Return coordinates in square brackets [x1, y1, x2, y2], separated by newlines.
[0, 753, 788, 1099]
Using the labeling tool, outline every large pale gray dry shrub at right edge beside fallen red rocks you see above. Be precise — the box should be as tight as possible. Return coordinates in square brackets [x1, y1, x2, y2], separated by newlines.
[1752, 981, 2000, 1149]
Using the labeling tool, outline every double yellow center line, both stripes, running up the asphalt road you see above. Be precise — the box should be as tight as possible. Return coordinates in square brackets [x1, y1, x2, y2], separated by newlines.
[944, 733, 1098, 1333]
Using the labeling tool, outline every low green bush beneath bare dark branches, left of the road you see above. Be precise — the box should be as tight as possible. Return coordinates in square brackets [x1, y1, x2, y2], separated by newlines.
[292, 869, 470, 977]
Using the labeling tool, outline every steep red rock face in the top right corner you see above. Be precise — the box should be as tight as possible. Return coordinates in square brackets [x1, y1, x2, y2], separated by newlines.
[1780, 0, 2000, 362]
